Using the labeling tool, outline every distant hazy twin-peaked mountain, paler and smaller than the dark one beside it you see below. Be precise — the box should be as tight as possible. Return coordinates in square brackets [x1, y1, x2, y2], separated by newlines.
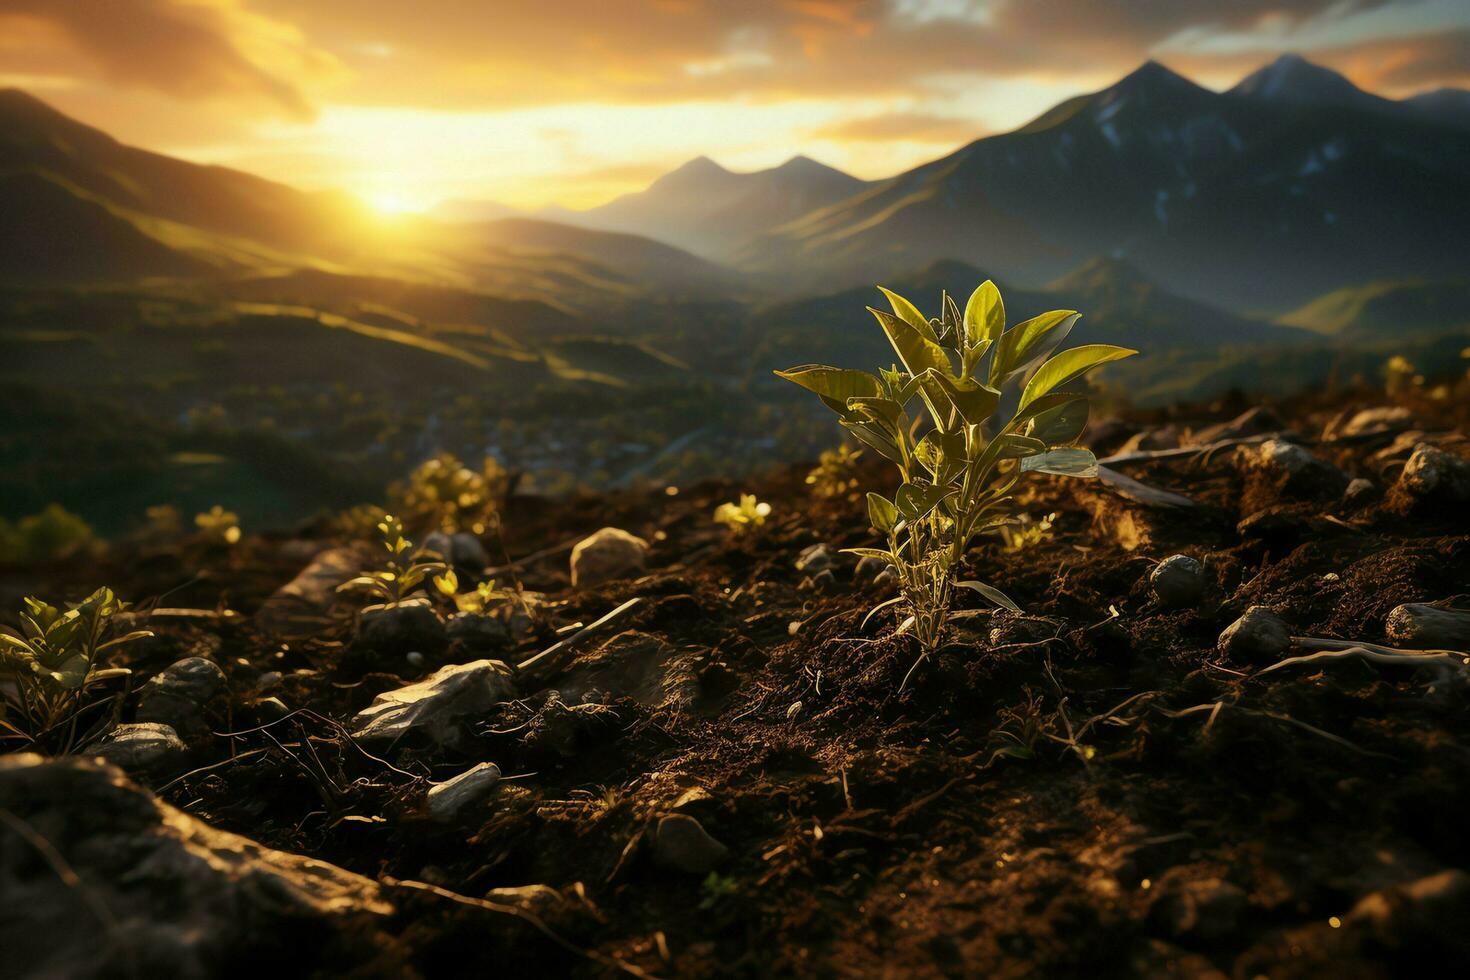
[562, 156, 866, 259]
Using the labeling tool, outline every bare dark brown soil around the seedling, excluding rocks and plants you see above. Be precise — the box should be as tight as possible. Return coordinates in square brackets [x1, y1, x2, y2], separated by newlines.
[3, 387, 1470, 977]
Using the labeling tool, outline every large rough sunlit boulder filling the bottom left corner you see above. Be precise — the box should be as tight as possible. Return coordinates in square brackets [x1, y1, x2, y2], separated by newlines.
[0, 754, 392, 979]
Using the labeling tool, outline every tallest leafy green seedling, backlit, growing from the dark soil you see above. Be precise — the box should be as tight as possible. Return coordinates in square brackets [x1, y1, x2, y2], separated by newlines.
[776, 281, 1138, 682]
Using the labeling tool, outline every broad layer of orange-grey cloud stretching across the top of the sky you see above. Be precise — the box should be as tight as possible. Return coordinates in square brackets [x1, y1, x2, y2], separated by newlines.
[0, 0, 1470, 119]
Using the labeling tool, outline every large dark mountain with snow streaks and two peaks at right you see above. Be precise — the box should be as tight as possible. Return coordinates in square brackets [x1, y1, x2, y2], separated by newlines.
[735, 60, 1470, 310]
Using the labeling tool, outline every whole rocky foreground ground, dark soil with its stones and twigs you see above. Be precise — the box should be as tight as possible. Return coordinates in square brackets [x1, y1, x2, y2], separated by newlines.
[0, 387, 1470, 977]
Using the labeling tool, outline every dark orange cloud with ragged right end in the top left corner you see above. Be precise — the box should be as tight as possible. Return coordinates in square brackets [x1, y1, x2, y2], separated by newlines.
[0, 0, 340, 119]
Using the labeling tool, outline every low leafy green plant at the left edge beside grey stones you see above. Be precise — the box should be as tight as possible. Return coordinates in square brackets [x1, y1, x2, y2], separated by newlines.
[0, 588, 153, 752]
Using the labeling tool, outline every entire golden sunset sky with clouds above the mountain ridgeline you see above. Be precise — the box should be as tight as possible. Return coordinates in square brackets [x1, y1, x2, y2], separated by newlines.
[0, 0, 1470, 210]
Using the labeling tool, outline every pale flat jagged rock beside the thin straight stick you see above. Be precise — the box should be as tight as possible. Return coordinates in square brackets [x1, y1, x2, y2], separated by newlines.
[353, 660, 516, 746]
